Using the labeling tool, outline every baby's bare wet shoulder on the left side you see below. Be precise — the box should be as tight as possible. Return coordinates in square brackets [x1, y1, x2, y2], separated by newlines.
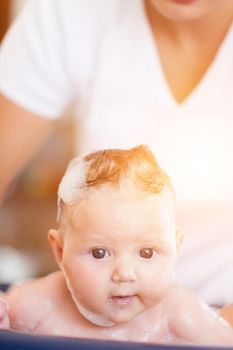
[4, 272, 65, 331]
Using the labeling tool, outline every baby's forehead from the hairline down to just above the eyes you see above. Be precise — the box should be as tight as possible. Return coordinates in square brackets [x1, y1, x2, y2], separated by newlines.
[62, 189, 175, 249]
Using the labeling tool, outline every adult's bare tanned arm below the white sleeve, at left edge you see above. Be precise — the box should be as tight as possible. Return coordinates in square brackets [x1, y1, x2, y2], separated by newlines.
[0, 95, 53, 199]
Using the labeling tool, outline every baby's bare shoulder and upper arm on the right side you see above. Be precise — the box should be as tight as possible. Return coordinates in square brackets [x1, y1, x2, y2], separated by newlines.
[170, 289, 233, 345]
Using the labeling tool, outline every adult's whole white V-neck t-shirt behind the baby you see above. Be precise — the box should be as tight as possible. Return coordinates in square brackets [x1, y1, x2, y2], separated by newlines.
[0, 0, 233, 304]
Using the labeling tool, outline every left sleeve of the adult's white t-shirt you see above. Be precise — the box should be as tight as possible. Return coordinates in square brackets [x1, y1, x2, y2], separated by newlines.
[0, 0, 73, 119]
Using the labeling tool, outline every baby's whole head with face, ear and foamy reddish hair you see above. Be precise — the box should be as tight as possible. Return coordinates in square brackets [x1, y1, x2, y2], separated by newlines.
[49, 146, 182, 326]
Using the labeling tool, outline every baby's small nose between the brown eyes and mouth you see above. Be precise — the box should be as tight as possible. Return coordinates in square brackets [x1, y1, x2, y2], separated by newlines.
[112, 259, 137, 283]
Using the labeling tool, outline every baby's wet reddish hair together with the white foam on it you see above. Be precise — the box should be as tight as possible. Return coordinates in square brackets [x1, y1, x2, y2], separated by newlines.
[58, 145, 173, 218]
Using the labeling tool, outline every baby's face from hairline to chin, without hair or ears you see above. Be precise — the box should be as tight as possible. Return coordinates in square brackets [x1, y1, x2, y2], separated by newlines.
[61, 188, 177, 323]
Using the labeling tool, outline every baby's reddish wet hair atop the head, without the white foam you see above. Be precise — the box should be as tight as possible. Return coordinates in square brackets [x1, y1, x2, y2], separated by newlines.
[84, 145, 172, 193]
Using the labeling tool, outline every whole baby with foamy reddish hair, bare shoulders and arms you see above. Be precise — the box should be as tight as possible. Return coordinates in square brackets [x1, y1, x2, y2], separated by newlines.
[0, 146, 233, 345]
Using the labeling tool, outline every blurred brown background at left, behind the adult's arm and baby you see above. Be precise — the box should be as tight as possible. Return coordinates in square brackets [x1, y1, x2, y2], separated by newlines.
[0, 0, 73, 290]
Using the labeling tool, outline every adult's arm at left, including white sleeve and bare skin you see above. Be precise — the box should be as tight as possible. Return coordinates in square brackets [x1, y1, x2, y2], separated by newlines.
[0, 0, 73, 201]
